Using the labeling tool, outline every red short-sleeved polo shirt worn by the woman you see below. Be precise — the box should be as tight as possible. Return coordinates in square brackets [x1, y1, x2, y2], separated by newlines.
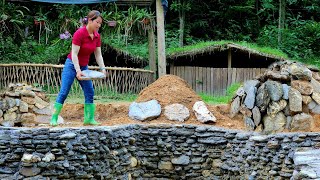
[68, 26, 101, 66]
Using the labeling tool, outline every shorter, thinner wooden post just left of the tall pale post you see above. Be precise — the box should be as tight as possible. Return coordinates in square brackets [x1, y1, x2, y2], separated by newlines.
[148, 20, 157, 79]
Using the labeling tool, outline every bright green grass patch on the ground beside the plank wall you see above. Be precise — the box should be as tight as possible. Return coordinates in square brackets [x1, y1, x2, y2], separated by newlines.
[199, 83, 241, 104]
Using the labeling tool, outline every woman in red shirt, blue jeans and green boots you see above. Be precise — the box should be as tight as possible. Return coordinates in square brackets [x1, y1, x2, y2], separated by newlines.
[50, 10, 107, 126]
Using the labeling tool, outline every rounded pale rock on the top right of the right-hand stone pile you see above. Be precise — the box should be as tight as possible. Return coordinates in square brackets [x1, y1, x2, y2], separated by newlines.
[289, 63, 312, 81]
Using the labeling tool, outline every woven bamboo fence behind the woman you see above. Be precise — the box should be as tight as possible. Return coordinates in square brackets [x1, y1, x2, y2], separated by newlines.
[0, 64, 154, 94]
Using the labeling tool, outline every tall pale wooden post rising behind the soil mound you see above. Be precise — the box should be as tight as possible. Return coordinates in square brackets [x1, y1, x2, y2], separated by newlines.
[156, 0, 167, 77]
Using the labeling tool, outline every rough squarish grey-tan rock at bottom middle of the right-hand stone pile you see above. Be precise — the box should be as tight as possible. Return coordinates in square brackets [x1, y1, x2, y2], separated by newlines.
[262, 112, 287, 134]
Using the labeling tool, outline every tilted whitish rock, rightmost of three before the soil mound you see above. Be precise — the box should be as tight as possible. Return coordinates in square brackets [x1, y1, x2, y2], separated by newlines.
[193, 101, 216, 123]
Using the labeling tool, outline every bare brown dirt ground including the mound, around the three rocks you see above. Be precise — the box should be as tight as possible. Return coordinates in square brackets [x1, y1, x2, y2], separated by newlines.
[52, 75, 320, 132]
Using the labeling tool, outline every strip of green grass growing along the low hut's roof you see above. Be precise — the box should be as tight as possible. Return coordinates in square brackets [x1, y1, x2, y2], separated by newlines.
[167, 41, 288, 59]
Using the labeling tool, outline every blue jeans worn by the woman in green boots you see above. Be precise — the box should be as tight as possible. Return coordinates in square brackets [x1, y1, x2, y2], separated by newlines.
[56, 58, 94, 104]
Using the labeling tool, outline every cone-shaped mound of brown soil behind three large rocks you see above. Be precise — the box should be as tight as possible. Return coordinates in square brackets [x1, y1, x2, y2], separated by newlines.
[136, 75, 201, 110]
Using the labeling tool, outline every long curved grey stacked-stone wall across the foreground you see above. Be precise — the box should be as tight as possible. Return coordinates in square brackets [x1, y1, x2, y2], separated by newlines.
[0, 125, 320, 179]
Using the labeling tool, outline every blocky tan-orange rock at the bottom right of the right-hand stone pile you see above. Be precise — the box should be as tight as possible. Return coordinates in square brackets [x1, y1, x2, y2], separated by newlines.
[291, 113, 313, 131]
